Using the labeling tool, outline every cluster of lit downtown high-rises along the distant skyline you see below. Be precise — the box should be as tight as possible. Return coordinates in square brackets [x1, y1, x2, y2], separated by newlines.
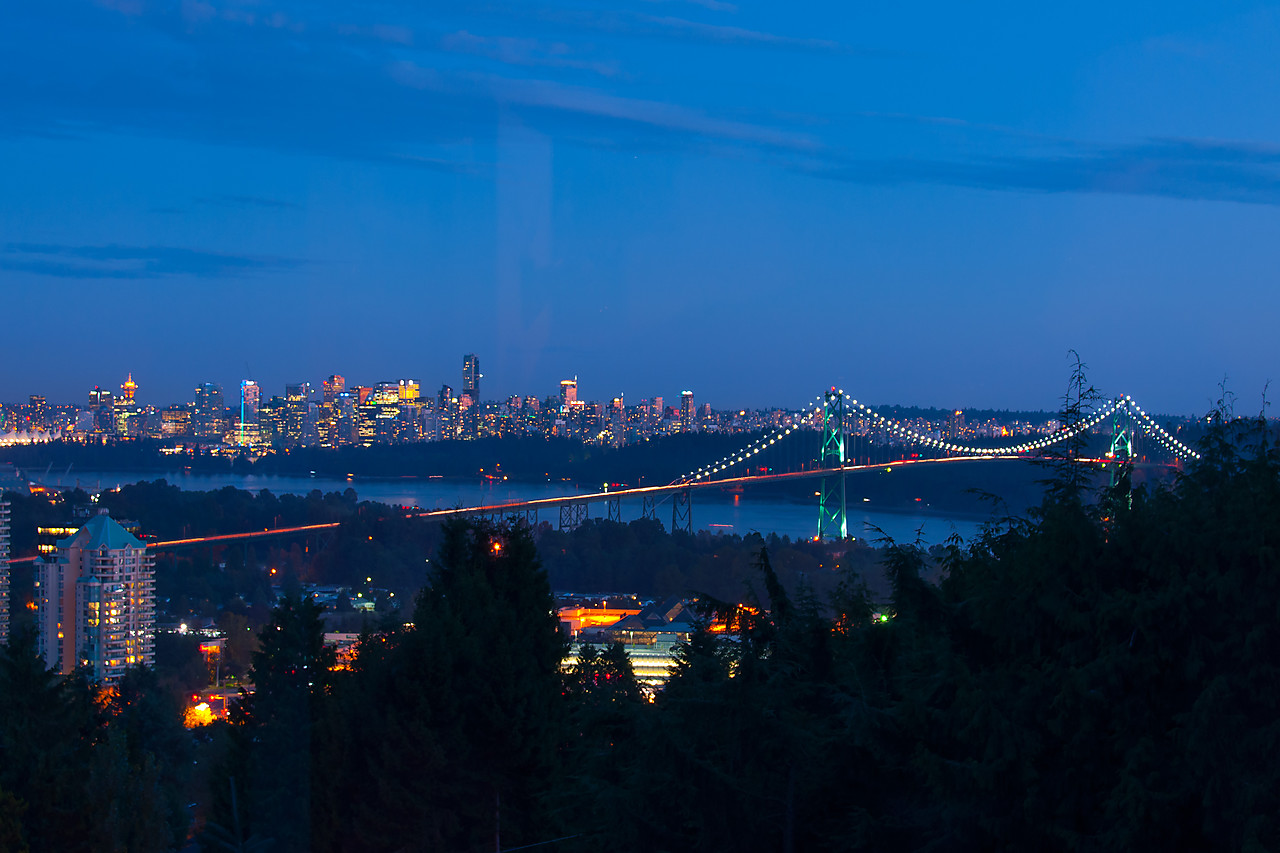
[0, 353, 742, 453]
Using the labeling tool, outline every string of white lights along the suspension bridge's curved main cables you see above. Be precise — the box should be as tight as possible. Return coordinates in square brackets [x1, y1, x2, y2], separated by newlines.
[676, 389, 1201, 483]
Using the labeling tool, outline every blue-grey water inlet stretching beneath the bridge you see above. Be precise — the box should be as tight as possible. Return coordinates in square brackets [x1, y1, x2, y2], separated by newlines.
[40, 471, 979, 544]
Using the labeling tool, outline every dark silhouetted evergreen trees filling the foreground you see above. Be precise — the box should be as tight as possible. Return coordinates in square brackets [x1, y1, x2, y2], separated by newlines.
[0, 409, 1280, 853]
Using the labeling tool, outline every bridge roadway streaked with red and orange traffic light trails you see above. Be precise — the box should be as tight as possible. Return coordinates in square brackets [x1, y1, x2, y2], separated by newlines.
[9, 453, 1107, 564]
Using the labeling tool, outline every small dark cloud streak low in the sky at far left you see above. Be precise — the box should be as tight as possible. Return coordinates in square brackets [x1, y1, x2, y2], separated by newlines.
[0, 243, 301, 279]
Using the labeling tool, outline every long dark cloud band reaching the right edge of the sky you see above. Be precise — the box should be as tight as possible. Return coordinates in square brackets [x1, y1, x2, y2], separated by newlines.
[805, 140, 1280, 205]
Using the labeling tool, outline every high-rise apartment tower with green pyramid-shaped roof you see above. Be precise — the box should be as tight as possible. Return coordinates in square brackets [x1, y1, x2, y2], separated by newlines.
[36, 510, 156, 683]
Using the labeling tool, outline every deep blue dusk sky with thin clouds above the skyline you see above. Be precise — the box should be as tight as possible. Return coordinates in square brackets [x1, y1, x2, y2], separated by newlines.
[0, 0, 1280, 414]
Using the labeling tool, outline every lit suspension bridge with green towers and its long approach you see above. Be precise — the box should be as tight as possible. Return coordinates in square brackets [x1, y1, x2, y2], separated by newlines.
[12, 388, 1199, 562]
